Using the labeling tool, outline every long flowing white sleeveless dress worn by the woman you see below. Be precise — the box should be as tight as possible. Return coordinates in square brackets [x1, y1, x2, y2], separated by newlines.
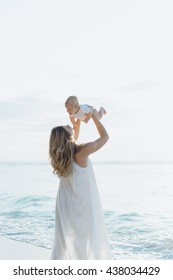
[51, 159, 111, 260]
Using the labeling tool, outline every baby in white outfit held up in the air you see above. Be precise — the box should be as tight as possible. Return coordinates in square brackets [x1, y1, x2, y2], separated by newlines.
[65, 95, 106, 123]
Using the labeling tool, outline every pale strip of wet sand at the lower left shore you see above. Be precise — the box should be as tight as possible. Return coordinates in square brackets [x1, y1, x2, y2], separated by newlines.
[0, 236, 51, 260]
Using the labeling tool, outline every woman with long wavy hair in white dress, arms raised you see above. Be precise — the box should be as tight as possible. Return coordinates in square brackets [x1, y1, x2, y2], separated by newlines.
[49, 110, 111, 260]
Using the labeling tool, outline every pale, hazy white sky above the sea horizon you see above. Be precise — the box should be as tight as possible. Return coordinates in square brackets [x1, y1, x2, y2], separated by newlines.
[0, 0, 173, 162]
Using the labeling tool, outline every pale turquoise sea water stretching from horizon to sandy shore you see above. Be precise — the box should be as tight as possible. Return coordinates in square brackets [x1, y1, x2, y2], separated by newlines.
[0, 162, 173, 260]
